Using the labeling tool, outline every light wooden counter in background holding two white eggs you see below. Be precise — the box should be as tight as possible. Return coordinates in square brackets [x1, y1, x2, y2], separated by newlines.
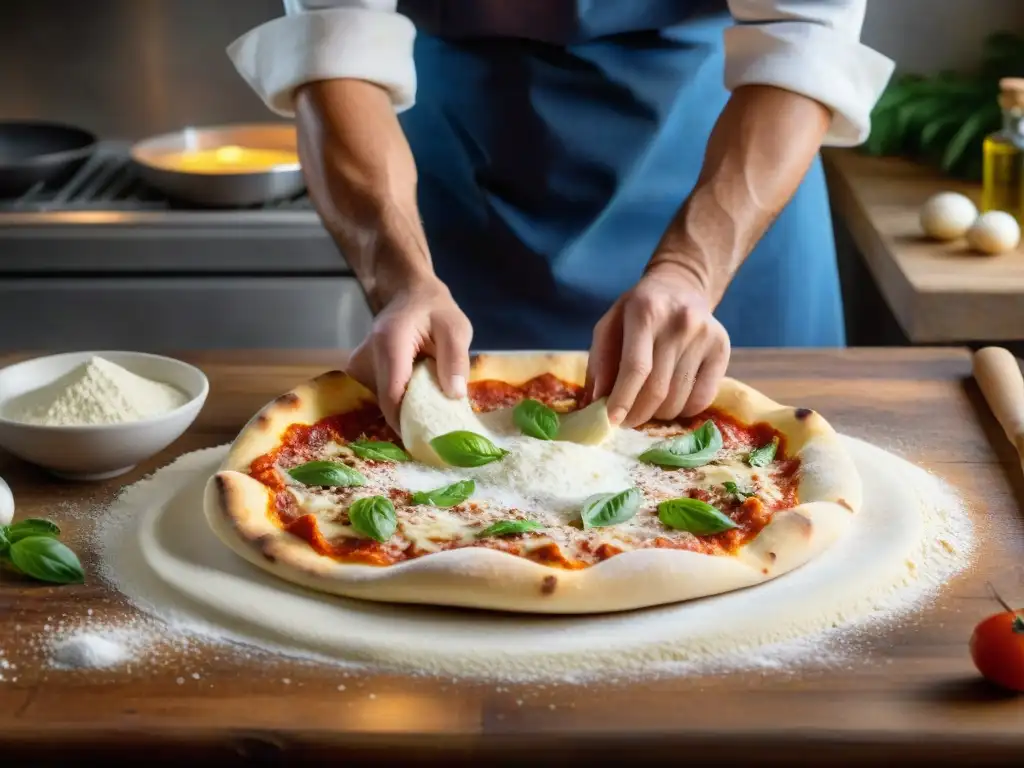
[824, 151, 1024, 344]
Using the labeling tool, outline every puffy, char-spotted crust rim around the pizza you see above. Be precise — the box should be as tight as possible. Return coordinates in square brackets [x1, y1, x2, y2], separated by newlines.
[205, 352, 861, 613]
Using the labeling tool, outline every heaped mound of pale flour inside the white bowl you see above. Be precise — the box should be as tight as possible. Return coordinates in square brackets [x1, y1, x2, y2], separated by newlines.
[6, 357, 188, 426]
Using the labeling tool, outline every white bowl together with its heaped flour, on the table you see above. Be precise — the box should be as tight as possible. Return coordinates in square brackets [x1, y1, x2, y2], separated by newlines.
[0, 351, 210, 480]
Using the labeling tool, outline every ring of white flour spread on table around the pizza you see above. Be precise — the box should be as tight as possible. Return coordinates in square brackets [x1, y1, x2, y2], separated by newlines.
[0, 438, 973, 684]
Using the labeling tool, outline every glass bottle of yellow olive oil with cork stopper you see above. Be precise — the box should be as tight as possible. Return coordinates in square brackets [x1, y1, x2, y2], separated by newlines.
[981, 78, 1024, 224]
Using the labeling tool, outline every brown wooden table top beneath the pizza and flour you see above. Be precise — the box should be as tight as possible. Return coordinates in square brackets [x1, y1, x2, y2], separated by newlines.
[0, 348, 1024, 766]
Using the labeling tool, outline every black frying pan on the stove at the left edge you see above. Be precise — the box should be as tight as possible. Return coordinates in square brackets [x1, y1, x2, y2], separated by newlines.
[0, 120, 96, 198]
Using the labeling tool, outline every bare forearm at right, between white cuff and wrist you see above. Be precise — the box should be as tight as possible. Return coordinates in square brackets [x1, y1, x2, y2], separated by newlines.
[648, 85, 830, 306]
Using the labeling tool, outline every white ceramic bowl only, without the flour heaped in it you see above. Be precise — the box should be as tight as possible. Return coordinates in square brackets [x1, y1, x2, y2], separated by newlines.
[0, 351, 210, 480]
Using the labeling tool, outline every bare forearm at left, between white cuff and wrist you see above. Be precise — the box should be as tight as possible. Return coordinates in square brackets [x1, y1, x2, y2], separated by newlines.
[295, 79, 433, 312]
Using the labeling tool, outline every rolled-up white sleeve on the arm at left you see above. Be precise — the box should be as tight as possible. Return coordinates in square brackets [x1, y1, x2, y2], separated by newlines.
[227, 0, 416, 117]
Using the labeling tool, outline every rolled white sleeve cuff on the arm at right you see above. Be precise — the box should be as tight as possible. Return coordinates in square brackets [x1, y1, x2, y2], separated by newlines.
[725, 22, 895, 146]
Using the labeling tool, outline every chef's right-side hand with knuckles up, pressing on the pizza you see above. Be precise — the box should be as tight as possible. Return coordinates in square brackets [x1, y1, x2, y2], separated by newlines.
[587, 263, 729, 427]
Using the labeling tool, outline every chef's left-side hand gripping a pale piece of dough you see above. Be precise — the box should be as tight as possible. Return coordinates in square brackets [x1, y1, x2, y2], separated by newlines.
[347, 278, 473, 432]
